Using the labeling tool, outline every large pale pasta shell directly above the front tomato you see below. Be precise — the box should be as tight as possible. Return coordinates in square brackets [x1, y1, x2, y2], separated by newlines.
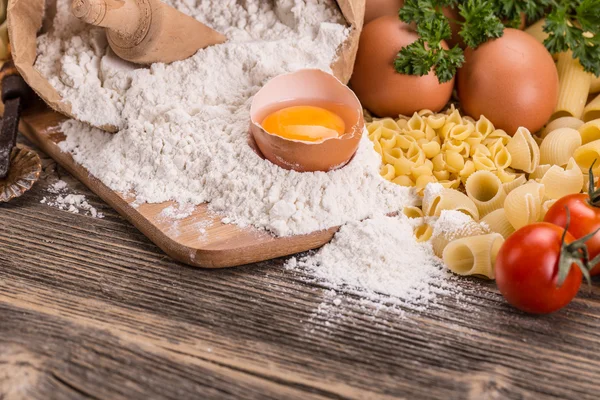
[504, 181, 545, 229]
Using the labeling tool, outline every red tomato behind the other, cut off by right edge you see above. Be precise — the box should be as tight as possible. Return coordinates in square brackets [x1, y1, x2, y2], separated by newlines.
[544, 193, 600, 275]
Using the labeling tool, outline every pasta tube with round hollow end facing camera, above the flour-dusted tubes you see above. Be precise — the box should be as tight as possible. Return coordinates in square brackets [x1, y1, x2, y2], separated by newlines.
[465, 171, 506, 218]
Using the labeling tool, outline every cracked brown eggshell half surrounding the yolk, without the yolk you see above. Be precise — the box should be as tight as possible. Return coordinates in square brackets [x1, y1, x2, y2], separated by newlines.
[250, 69, 364, 172]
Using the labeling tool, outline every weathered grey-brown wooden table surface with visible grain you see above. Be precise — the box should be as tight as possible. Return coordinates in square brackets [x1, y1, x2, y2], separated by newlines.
[0, 138, 600, 400]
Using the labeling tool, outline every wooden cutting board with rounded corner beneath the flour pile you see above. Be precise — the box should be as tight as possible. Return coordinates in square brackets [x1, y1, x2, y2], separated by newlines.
[20, 104, 337, 268]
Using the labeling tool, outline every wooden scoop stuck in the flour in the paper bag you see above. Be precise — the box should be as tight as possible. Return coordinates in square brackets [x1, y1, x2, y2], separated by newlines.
[71, 0, 226, 64]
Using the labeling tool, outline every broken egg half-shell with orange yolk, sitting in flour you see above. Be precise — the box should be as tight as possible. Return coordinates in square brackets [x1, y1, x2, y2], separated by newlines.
[250, 69, 364, 172]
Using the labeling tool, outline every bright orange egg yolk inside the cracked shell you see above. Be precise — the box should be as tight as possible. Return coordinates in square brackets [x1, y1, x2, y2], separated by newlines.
[262, 106, 346, 142]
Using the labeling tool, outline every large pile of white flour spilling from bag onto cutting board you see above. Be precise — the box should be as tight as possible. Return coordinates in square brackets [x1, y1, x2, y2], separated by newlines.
[35, 0, 415, 235]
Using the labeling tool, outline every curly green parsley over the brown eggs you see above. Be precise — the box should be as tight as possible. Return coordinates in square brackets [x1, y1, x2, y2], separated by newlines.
[394, 0, 600, 83]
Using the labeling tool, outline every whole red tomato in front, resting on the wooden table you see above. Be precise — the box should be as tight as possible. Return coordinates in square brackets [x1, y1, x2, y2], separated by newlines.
[496, 222, 582, 314]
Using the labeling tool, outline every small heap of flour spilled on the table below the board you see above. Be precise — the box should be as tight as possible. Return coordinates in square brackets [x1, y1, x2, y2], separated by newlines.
[286, 215, 451, 309]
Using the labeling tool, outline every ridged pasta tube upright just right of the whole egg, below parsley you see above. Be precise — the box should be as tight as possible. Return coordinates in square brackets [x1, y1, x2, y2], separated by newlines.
[552, 51, 592, 119]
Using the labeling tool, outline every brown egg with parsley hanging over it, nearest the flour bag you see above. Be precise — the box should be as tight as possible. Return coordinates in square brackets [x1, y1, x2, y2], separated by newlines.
[350, 16, 454, 117]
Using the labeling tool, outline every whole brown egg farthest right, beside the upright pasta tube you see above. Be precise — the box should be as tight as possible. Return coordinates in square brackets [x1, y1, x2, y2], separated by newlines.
[457, 28, 558, 135]
